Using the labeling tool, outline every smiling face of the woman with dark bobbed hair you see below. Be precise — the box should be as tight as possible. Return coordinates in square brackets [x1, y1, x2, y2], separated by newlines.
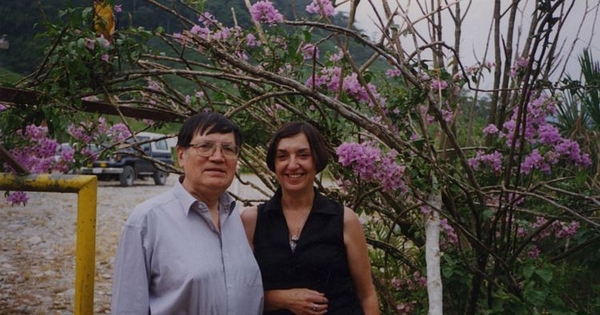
[275, 133, 317, 191]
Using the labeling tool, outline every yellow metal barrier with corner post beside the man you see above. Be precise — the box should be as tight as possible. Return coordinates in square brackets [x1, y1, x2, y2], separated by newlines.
[0, 173, 98, 315]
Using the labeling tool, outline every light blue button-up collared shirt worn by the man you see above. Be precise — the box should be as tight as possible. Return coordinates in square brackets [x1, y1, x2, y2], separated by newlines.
[112, 181, 263, 315]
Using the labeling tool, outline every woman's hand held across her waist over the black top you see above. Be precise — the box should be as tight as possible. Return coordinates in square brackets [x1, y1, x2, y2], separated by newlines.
[265, 288, 329, 315]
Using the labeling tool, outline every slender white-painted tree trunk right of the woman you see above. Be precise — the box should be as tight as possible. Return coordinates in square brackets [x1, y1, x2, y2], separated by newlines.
[425, 191, 443, 315]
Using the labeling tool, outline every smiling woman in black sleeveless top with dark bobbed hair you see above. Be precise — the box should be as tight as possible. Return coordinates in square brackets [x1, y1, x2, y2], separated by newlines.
[242, 122, 379, 315]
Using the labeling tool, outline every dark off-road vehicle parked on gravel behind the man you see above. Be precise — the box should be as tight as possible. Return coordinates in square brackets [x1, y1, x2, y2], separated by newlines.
[79, 132, 173, 187]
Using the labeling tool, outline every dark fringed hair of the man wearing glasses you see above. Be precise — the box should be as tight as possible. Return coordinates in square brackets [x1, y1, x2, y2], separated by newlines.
[177, 112, 243, 150]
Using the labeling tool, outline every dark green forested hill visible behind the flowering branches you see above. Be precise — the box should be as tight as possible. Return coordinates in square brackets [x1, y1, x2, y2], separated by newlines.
[0, 0, 356, 74]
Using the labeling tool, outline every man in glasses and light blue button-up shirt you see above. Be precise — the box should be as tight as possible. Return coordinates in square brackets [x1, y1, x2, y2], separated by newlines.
[112, 112, 263, 315]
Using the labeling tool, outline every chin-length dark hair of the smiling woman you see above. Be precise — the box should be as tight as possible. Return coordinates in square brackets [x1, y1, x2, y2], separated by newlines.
[267, 122, 329, 173]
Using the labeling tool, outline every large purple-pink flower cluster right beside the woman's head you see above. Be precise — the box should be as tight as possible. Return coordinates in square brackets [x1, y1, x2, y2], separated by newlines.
[336, 143, 406, 192]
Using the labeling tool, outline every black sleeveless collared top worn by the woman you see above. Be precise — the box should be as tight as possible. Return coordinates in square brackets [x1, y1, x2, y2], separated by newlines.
[254, 189, 364, 315]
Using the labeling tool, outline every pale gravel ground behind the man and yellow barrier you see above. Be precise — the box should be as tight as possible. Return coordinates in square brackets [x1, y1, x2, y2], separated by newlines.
[0, 175, 262, 315]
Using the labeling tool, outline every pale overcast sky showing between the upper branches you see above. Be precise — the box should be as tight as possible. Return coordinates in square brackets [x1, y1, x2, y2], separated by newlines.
[339, 0, 600, 81]
